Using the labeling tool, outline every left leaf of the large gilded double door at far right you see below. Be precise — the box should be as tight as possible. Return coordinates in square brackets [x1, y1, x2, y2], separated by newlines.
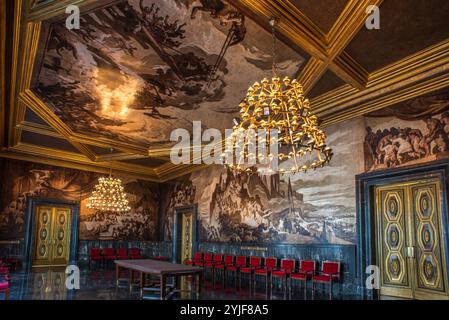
[377, 186, 412, 297]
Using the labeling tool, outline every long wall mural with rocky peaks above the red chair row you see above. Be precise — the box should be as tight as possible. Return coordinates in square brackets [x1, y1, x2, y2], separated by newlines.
[163, 119, 364, 244]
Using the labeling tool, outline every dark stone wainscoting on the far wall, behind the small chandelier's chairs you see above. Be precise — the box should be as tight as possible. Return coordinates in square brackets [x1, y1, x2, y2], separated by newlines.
[78, 240, 173, 264]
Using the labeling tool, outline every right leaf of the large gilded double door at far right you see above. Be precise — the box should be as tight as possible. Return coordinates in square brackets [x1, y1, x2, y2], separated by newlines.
[411, 182, 446, 296]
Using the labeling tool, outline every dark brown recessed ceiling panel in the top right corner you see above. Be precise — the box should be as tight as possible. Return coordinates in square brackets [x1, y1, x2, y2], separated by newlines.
[346, 0, 449, 72]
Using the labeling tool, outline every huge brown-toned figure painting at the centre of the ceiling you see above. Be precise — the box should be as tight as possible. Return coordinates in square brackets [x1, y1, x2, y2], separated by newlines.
[34, 0, 304, 148]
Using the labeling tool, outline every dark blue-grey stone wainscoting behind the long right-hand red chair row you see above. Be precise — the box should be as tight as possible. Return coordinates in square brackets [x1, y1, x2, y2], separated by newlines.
[198, 242, 361, 294]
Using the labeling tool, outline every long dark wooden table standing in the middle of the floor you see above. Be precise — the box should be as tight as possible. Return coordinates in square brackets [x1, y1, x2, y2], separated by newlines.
[114, 259, 203, 300]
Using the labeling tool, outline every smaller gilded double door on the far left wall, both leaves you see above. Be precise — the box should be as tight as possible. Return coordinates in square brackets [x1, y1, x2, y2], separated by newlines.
[33, 206, 71, 267]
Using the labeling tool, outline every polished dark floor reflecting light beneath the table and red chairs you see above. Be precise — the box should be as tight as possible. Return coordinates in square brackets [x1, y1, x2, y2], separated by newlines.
[4, 268, 360, 300]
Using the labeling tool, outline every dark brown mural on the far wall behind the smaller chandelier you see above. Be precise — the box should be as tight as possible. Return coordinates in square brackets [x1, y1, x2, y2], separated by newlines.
[0, 160, 159, 240]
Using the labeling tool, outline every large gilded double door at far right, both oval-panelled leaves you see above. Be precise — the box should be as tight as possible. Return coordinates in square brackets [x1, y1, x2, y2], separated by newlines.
[375, 180, 448, 299]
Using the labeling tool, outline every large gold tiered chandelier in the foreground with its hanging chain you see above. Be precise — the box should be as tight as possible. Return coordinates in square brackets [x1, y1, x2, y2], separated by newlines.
[224, 20, 333, 174]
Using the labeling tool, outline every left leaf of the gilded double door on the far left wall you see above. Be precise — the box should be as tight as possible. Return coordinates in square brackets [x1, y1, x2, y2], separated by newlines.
[33, 207, 53, 265]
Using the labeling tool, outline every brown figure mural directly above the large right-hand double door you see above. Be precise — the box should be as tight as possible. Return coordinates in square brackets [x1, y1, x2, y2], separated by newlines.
[365, 92, 449, 171]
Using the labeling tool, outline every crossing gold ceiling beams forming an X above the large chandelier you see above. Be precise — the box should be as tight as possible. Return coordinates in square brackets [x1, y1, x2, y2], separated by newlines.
[234, 0, 382, 93]
